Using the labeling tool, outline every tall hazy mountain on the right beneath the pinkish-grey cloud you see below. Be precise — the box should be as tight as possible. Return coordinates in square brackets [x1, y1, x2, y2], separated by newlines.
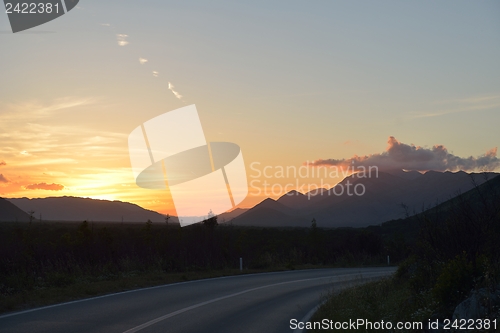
[232, 170, 497, 227]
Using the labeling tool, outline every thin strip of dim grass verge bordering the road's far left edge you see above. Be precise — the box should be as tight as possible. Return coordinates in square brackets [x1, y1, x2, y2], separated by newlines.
[0, 265, 326, 313]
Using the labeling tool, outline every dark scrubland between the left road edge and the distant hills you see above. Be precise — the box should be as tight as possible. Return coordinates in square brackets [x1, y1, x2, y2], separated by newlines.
[0, 217, 387, 312]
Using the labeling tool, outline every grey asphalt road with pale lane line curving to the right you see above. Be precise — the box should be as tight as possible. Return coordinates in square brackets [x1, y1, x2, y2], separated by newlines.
[0, 267, 395, 333]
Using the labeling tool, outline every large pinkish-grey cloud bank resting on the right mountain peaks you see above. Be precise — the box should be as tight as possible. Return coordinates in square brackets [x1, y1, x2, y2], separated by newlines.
[304, 136, 500, 171]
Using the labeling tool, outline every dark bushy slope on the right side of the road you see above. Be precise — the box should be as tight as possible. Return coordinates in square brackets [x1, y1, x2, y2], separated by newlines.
[311, 177, 500, 332]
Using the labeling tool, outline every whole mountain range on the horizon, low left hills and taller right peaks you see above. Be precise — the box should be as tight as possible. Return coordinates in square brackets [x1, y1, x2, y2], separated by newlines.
[0, 170, 498, 227]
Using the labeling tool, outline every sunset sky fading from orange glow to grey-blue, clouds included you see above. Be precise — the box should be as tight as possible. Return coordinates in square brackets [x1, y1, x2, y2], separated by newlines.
[0, 0, 500, 213]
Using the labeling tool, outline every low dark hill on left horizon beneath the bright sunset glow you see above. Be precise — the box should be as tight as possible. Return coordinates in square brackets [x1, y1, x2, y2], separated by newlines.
[7, 197, 170, 223]
